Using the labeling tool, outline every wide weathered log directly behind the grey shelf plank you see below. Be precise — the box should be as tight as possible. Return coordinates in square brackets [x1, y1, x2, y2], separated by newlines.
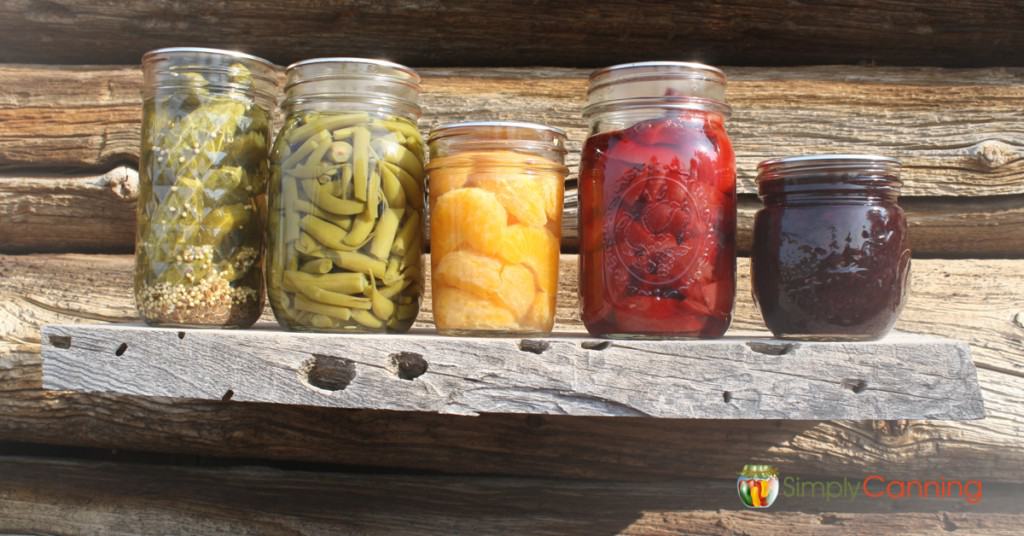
[0, 255, 1024, 482]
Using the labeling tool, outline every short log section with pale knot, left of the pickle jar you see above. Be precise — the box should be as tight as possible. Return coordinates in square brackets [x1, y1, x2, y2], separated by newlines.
[0, 166, 138, 253]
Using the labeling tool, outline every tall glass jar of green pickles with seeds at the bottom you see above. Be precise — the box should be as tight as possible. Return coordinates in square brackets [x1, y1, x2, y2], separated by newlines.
[135, 48, 276, 328]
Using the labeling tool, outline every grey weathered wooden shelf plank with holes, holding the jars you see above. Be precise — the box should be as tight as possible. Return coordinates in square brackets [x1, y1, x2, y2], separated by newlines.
[42, 324, 984, 420]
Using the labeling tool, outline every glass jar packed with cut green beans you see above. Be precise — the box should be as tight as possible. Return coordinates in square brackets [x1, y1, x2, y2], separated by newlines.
[267, 57, 425, 332]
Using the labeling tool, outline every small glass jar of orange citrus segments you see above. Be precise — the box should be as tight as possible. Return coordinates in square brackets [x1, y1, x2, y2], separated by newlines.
[427, 121, 567, 334]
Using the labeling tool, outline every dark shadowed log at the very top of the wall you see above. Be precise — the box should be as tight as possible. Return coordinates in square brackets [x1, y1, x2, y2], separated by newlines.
[0, 0, 1024, 66]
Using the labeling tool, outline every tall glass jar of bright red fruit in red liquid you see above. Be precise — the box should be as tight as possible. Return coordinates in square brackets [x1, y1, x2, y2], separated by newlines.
[580, 61, 736, 337]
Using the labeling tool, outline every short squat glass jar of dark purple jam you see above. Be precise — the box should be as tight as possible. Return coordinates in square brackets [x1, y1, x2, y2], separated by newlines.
[751, 155, 910, 340]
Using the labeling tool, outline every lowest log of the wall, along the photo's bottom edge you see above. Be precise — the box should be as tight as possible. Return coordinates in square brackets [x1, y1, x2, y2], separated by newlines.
[0, 456, 1024, 536]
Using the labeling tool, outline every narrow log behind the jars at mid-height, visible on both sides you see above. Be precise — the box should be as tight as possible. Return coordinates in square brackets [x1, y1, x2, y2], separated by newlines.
[8, 170, 1024, 258]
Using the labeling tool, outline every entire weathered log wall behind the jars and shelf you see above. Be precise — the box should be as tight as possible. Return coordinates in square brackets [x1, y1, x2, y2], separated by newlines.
[0, 0, 1024, 534]
